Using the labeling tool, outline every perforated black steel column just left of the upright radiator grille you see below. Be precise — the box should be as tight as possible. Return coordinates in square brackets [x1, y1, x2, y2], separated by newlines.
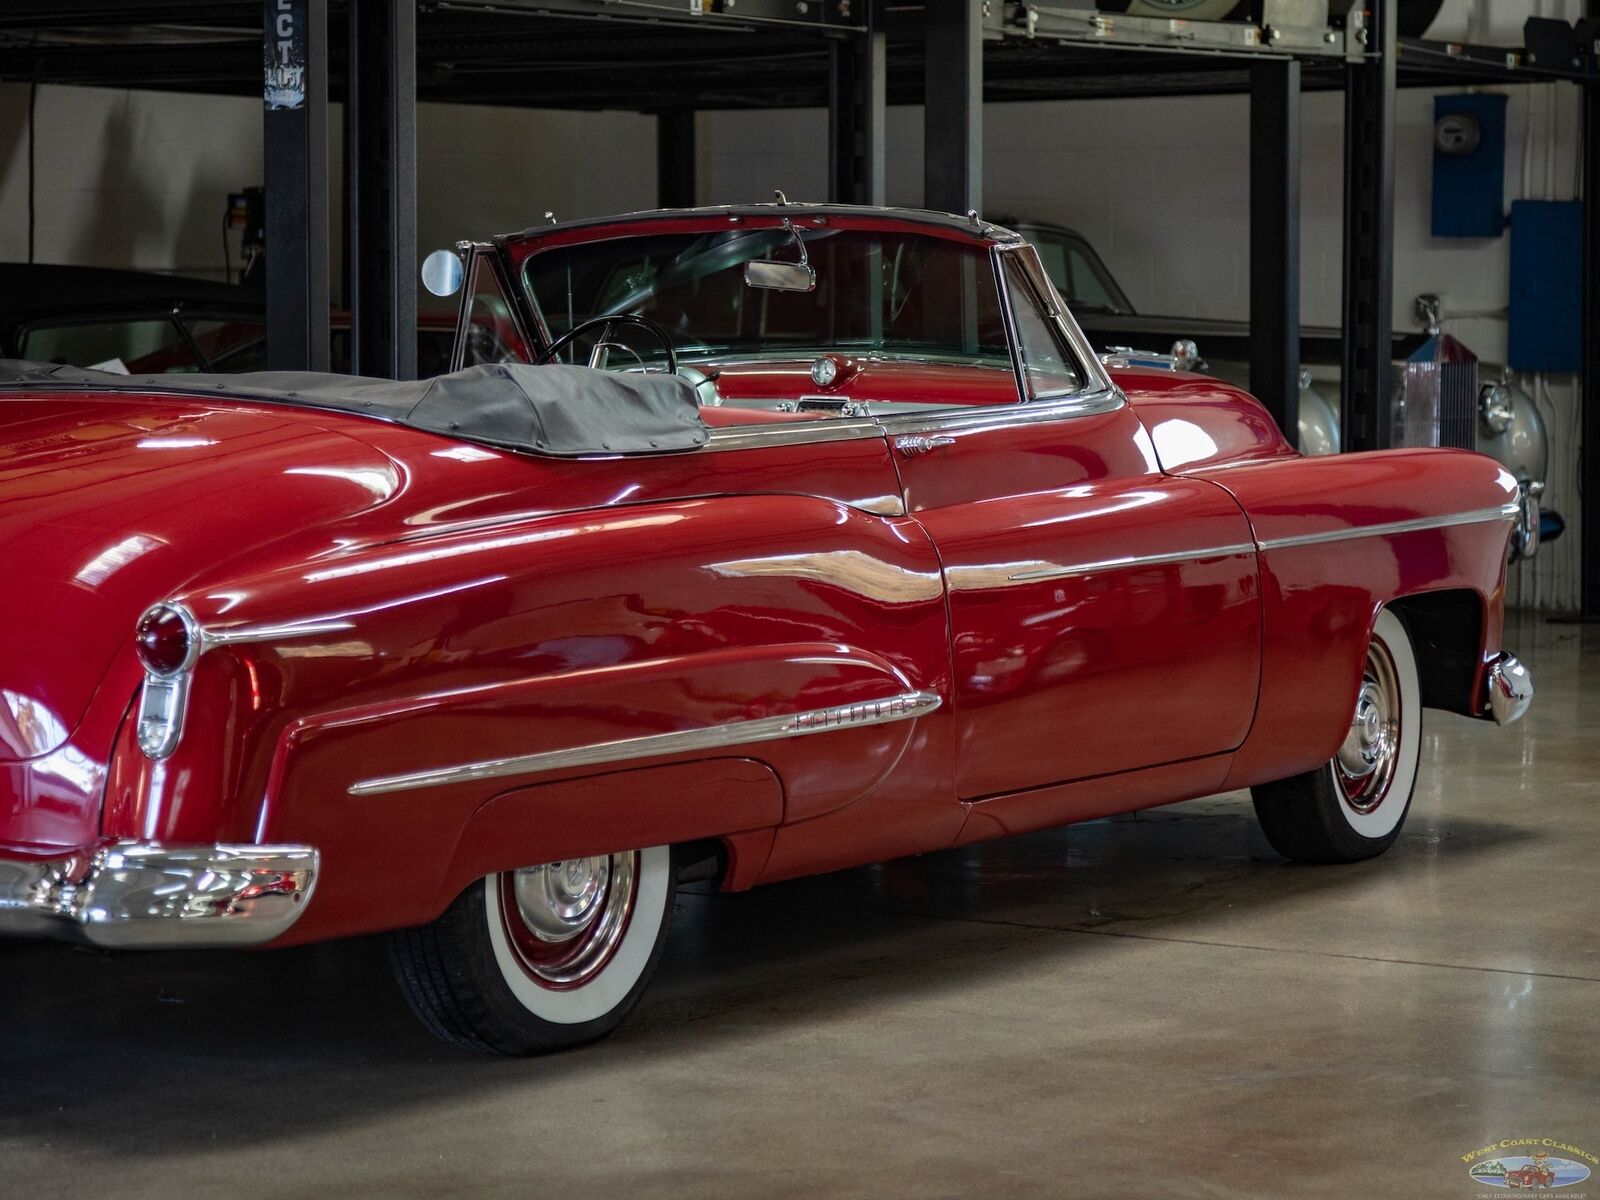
[1341, 0, 1397, 450]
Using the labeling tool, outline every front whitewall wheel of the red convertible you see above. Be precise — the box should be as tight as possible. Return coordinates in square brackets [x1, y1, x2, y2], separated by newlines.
[1251, 610, 1422, 862]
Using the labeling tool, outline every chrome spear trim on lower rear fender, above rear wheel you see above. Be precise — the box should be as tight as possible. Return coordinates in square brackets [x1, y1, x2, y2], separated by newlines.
[350, 691, 941, 795]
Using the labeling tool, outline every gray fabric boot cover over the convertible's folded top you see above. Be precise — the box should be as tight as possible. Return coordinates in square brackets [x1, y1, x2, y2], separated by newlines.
[0, 358, 710, 458]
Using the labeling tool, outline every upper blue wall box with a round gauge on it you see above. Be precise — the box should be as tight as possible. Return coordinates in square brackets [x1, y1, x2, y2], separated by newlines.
[1432, 96, 1506, 237]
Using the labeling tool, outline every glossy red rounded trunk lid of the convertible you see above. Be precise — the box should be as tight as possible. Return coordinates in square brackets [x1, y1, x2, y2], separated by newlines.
[0, 394, 400, 763]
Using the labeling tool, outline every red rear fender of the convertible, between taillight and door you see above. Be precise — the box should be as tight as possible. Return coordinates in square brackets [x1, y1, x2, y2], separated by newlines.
[106, 496, 958, 938]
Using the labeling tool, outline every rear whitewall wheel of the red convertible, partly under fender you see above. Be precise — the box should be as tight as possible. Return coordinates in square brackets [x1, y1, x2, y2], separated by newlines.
[389, 846, 675, 1054]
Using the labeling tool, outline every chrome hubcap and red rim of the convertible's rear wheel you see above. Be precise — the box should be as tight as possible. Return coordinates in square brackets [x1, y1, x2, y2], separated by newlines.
[499, 853, 638, 987]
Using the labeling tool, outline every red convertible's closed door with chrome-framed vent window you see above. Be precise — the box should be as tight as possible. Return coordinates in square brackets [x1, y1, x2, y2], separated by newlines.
[883, 248, 1261, 800]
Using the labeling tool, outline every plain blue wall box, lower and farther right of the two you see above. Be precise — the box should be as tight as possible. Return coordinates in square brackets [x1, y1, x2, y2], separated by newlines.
[1507, 200, 1584, 374]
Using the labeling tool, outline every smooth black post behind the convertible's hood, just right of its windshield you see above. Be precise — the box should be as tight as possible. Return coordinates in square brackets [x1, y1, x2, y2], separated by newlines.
[1250, 59, 1301, 443]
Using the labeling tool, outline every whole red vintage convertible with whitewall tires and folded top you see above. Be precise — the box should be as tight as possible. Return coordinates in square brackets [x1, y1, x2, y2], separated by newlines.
[0, 203, 1531, 1053]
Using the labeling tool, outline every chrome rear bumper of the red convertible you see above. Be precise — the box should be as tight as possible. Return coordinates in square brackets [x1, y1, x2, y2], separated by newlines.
[0, 842, 318, 949]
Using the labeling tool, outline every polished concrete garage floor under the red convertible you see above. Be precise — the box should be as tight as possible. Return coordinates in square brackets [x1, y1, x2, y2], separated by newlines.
[0, 619, 1600, 1200]
